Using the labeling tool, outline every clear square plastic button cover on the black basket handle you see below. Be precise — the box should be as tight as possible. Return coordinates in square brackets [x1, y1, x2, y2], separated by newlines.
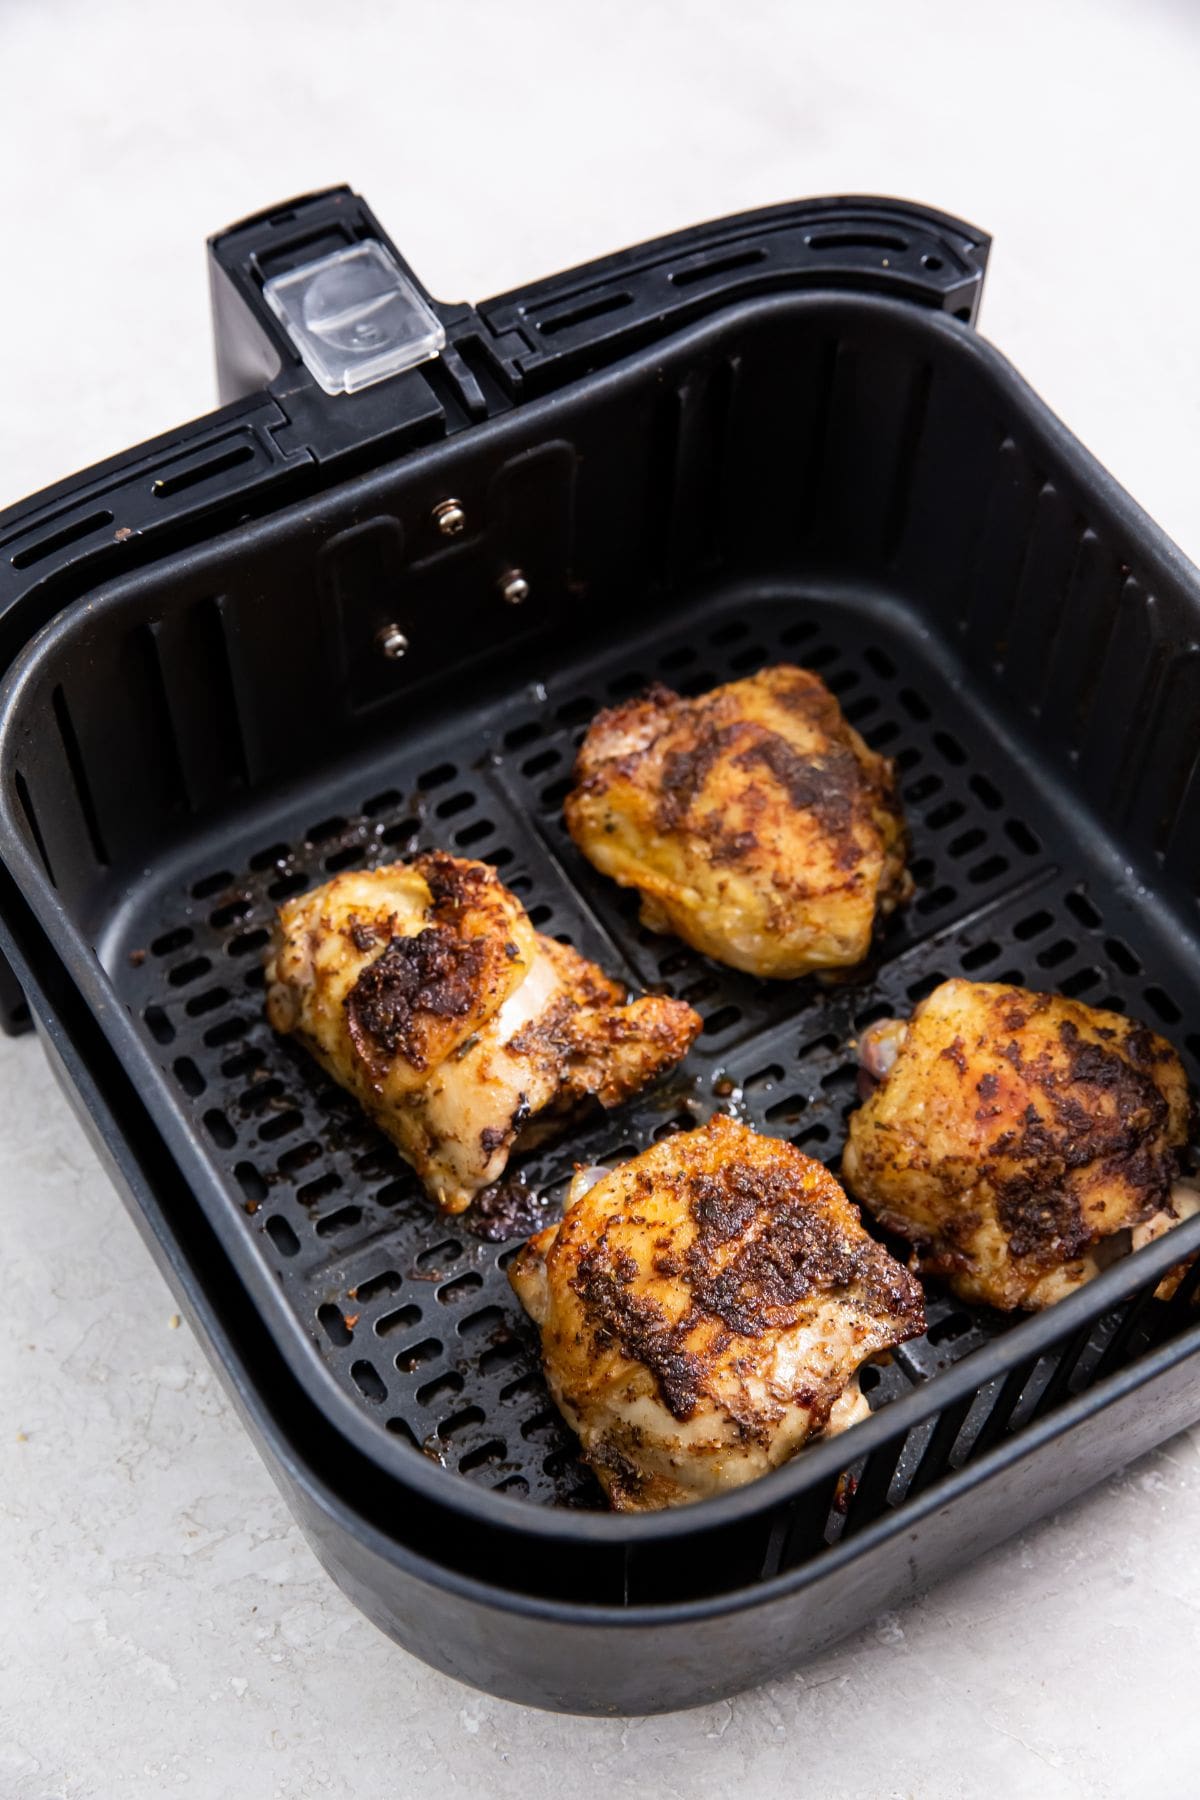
[263, 238, 446, 394]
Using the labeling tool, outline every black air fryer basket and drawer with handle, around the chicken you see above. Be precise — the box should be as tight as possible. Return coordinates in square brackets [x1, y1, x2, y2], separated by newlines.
[0, 189, 1200, 1712]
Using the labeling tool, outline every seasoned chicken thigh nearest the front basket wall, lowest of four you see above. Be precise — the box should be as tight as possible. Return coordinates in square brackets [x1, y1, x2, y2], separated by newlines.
[509, 1114, 925, 1512]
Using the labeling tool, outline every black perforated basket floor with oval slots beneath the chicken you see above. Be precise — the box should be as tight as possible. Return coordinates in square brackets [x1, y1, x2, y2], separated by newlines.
[101, 592, 1200, 1507]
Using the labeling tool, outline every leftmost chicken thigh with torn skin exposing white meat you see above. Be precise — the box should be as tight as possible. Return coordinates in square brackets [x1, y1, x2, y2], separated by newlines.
[266, 851, 700, 1213]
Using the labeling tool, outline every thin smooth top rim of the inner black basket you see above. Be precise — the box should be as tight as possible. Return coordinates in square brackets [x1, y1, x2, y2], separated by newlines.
[0, 280, 1200, 1544]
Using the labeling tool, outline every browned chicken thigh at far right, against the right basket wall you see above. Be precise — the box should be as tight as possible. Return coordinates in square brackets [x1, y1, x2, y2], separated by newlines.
[842, 981, 1195, 1310]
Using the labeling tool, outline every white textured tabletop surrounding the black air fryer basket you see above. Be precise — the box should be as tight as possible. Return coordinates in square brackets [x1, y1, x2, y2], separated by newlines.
[0, 0, 1200, 1800]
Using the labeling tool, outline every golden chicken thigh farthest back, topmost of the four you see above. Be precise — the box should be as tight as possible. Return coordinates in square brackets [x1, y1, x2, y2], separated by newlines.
[565, 664, 910, 977]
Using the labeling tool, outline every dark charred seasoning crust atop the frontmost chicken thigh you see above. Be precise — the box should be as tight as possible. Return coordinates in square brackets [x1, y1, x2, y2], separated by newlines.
[570, 1156, 925, 1418]
